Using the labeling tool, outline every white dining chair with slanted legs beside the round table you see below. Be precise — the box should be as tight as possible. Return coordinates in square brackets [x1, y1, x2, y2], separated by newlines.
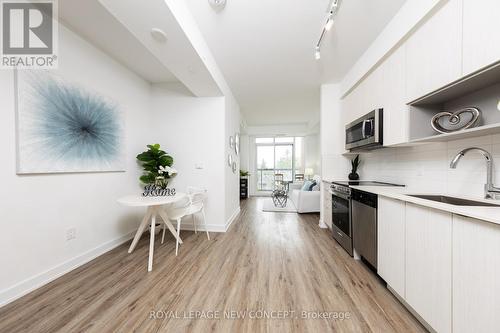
[161, 186, 210, 255]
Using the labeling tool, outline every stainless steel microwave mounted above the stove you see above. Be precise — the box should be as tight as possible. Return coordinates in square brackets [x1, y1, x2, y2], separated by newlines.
[345, 109, 384, 150]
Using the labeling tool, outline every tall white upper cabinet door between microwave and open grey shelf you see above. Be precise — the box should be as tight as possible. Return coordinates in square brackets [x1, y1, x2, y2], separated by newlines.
[379, 45, 409, 146]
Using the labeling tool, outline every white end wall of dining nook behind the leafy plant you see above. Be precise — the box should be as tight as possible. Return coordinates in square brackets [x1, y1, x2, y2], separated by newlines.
[151, 83, 228, 231]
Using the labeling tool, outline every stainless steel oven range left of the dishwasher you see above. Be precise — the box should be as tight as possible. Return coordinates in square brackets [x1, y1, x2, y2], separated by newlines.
[330, 184, 353, 256]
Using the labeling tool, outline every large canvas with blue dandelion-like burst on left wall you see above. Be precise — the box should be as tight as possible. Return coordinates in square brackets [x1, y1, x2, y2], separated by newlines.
[17, 70, 125, 174]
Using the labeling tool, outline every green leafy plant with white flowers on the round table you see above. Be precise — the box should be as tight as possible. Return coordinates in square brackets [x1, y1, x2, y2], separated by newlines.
[137, 143, 177, 188]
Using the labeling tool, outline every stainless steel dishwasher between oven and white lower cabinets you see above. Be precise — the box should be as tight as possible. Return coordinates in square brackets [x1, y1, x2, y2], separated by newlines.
[351, 190, 377, 270]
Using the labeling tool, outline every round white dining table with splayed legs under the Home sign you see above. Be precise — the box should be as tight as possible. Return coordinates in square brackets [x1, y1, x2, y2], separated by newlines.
[117, 192, 186, 272]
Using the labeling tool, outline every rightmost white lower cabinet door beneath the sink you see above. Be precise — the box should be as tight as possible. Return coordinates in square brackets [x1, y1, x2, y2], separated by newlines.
[453, 215, 500, 333]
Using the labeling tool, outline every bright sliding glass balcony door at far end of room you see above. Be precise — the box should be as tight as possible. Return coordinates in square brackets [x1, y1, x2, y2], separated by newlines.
[255, 137, 302, 191]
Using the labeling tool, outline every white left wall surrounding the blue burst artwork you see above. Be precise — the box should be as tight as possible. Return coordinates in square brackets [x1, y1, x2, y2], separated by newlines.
[0, 26, 151, 304]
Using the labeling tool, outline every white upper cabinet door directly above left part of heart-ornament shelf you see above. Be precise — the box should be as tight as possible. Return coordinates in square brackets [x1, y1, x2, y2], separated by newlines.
[406, 0, 460, 102]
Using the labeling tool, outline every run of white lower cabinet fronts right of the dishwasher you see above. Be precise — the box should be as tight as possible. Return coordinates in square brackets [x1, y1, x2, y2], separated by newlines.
[377, 196, 500, 333]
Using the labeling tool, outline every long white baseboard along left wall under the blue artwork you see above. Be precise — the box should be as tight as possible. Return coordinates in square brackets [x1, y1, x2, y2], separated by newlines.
[0, 229, 136, 307]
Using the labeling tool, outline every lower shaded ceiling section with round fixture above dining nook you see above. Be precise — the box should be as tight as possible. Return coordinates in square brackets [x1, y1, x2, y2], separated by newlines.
[59, 0, 178, 83]
